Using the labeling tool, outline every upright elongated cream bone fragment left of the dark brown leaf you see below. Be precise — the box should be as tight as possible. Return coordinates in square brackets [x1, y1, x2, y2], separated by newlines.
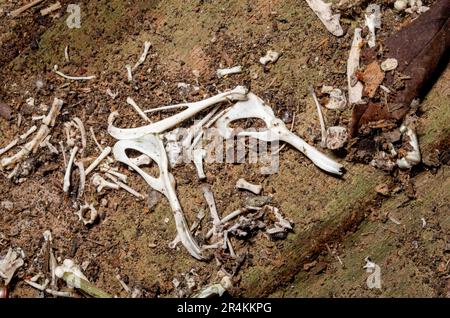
[347, 28, 364, 104]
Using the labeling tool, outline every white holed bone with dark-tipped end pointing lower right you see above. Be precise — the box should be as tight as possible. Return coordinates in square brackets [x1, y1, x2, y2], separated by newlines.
[216, 93, 344, 175]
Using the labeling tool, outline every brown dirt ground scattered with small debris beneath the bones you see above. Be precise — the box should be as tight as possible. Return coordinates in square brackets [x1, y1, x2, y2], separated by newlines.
[0, 0, 450, 297]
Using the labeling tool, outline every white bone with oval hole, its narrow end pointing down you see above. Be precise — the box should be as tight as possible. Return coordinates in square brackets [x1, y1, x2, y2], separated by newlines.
[113, 135, 203, 260]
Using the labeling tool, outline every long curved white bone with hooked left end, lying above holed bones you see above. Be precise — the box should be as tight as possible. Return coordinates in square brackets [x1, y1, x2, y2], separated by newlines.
[108, 86, 247, 140]
